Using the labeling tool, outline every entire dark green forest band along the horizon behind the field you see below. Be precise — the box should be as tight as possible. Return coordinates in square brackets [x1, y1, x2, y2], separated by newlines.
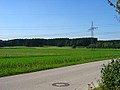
[0, 38, 120, 48]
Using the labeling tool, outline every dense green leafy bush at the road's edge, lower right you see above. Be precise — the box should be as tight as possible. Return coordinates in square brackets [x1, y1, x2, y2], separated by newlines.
[100, 59, 120, 90]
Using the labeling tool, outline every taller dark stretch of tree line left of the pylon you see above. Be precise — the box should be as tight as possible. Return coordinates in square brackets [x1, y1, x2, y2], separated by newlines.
[0, 38, 97, 47]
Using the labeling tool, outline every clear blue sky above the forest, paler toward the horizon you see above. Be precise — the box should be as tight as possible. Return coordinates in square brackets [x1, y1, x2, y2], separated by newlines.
[0, 0, 120, 40]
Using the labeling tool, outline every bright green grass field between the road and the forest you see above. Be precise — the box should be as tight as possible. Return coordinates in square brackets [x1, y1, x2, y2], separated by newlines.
[0, 47, 120, 77]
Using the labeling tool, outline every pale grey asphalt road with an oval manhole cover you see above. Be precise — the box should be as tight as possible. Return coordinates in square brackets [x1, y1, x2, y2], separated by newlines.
[0, 60, 109, 90]
